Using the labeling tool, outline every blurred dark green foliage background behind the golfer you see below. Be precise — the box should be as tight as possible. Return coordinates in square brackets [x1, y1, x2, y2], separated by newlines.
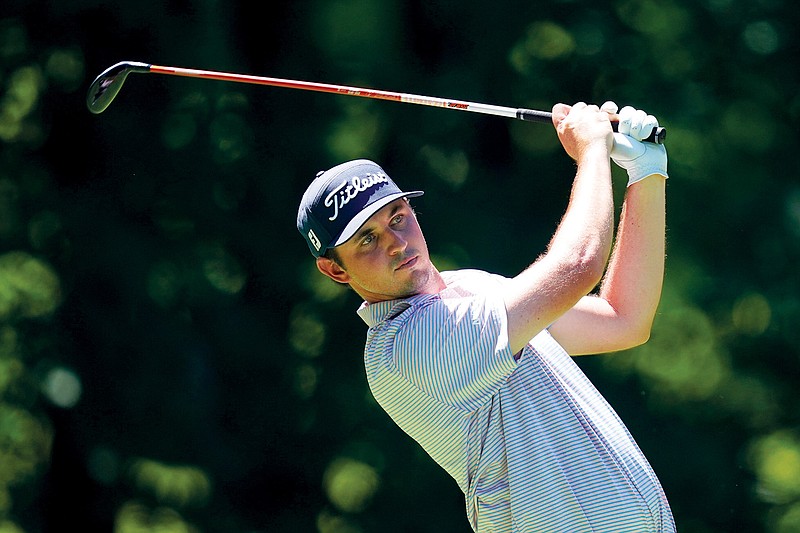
[0, 0, 800, 533]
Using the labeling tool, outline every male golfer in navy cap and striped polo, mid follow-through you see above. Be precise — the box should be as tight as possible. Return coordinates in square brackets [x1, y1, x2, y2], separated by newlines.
[297, 102, 675, 533]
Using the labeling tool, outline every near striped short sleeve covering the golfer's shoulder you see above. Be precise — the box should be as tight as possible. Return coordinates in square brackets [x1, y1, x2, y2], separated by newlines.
[394, 294, 517, 410]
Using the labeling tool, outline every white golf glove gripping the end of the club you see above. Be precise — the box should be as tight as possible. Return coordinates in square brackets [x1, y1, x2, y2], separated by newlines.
[600, 102, 669, 187]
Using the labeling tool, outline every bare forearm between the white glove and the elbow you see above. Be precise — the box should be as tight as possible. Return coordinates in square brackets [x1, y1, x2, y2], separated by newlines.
[599, 175, 666, 345]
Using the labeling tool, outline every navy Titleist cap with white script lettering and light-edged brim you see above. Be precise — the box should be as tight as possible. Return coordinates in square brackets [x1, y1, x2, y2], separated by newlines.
[297, 159, 423, 257]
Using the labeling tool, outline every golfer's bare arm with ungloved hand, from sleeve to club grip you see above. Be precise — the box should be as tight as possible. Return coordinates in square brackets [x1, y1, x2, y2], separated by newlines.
[503, 103, 614, 353]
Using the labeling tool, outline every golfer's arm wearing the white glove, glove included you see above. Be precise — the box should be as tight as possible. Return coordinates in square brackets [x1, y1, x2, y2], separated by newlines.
[550, 103, 667, 355]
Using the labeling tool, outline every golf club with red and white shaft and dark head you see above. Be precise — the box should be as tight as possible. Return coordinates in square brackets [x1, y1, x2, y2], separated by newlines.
[86, 61, 667, 144]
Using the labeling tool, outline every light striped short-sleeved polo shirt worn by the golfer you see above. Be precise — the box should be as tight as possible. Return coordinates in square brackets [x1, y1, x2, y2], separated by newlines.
[358, 270, 675, 533]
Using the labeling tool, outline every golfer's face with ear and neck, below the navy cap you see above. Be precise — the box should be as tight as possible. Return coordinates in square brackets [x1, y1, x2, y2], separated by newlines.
[317, 199, 444, 303]
